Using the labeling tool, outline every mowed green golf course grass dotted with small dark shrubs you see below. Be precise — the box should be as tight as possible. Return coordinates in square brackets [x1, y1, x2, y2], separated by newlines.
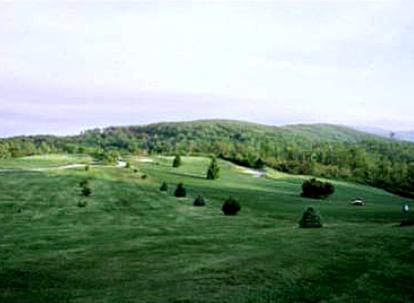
[0, 156, 414, 303]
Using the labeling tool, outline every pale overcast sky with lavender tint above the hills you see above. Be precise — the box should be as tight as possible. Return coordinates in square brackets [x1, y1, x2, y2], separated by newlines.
[0, 0, 414, 136]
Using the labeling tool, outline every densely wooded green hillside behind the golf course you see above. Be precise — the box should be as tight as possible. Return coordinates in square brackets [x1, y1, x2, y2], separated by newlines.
[0, 120, 414, 196]
